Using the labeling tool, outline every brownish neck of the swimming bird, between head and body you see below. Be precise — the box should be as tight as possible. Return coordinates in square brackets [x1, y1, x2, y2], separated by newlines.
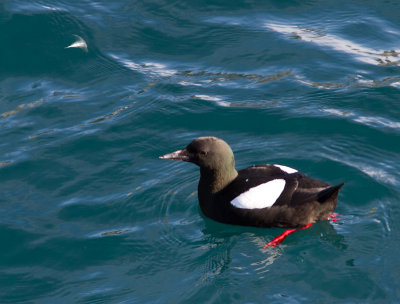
[199, 167, 238, 194]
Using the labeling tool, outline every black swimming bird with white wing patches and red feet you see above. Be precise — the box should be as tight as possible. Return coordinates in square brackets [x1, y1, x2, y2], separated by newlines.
[160, 136, 344, 246]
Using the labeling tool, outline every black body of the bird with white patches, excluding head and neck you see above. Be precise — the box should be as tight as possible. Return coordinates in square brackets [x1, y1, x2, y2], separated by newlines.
[199, 165, 342, 227]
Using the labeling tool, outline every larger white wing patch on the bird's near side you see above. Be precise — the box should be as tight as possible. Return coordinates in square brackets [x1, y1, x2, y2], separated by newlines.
[231, 179, 286, 209]
